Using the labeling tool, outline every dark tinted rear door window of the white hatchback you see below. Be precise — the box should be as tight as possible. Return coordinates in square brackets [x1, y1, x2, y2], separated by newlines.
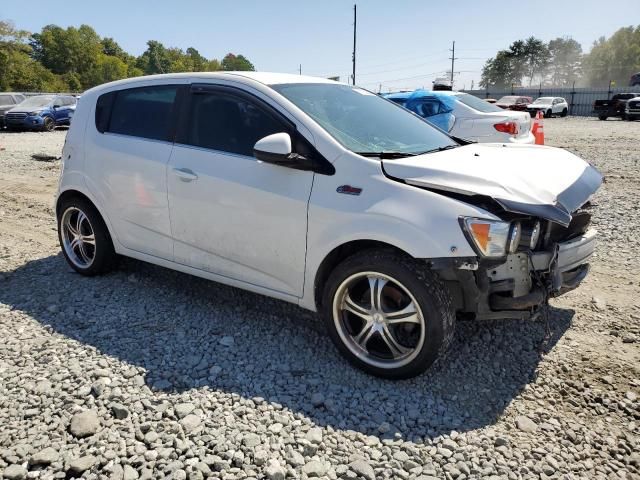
[107, 85, 178, 140]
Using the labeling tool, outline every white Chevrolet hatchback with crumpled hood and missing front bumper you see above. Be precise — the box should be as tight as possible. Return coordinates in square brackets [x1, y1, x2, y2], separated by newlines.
[56, 72, 601, 378]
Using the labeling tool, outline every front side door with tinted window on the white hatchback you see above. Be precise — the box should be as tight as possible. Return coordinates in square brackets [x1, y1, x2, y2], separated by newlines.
[167, 86, 313, 296]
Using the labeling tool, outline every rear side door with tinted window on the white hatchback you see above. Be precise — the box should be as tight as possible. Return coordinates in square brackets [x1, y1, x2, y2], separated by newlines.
[85, 83, 182, 260]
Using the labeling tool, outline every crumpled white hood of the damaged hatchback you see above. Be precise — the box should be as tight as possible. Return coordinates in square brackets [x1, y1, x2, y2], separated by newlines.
[382, 143, 602, 226]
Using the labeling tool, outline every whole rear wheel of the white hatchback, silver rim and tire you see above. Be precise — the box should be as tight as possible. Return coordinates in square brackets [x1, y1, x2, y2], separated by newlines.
[58, 197, 116, 276]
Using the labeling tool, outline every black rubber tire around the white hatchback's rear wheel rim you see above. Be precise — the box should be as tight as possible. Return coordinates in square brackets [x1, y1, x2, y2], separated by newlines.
[57, 197, 117, 277]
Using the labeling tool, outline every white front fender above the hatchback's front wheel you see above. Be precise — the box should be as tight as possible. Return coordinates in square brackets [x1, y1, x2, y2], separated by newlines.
[300, 157, 497, 310]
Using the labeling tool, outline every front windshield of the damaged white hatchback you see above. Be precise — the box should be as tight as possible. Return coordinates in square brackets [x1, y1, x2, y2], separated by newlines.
[273, 83, 457, 155]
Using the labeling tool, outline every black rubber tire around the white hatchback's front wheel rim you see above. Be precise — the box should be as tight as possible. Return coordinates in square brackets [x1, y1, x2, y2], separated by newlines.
[322, 249, 456, 379]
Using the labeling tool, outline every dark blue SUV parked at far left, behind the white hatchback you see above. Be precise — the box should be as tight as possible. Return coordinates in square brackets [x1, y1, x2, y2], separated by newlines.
[4, 95, 76, 132]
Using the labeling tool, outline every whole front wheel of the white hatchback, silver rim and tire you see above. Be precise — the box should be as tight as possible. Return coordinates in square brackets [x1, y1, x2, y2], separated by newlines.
[322, 250, 455, 379]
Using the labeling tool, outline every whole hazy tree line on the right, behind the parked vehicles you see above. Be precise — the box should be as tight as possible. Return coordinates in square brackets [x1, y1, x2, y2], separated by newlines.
[480, 25, 640, 88]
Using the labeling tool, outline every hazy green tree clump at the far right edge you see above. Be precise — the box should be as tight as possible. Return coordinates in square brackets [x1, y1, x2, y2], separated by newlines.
[583, 25, 640, 86]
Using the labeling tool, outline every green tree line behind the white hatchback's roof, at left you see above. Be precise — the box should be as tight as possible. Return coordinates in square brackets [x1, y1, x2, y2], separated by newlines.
[0, 20, 255, 92]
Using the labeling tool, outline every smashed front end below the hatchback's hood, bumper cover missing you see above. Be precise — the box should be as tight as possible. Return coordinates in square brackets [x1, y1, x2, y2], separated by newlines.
[432, 206, 596, 319]
